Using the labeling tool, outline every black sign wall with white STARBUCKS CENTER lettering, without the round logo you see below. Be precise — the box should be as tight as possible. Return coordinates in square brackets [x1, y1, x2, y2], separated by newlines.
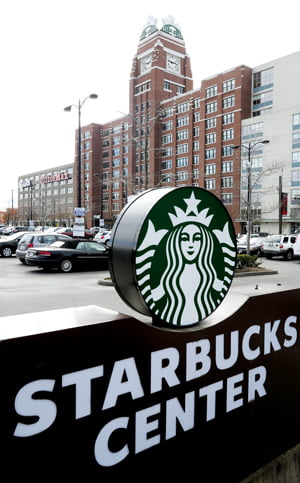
[0, 289, 300, 483]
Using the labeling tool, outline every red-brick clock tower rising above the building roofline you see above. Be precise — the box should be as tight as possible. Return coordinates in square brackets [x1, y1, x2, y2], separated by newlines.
[129, 17, 193, 189]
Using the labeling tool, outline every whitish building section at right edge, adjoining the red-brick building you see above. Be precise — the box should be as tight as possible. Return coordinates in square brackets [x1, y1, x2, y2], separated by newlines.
[241, 52, 300, 233]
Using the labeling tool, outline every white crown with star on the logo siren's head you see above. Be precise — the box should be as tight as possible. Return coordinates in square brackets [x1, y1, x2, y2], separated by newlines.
[169, 192, 214, 226]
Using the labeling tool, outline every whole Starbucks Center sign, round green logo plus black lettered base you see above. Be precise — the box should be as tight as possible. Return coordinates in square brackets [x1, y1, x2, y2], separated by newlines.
[0, 187, 300, 483]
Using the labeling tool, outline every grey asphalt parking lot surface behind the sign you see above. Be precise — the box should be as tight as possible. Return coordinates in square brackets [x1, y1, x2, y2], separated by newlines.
[0, 256, 300, 321]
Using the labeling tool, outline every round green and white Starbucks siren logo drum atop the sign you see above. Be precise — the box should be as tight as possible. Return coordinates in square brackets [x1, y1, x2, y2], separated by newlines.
[112, 187, 236, 327]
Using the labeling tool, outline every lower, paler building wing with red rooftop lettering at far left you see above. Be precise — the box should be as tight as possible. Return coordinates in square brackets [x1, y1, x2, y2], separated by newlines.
[18, 163, 74, 226]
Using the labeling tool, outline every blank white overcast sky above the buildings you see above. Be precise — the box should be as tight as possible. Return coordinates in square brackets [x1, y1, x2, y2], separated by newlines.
[0, 0, 300, 210]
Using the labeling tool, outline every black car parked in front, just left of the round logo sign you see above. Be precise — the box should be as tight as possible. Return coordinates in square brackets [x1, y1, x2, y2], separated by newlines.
[25, 238, 109, 273]
